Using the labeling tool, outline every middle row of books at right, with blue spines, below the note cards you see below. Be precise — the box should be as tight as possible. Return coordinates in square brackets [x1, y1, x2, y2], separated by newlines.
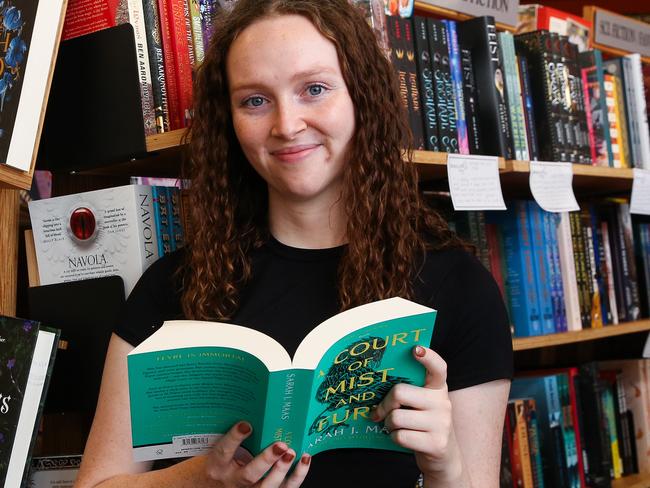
[442, 200, 650, 337]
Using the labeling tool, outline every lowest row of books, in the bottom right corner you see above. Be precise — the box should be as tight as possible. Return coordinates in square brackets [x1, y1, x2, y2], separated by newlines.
[500, 359, 650, 488]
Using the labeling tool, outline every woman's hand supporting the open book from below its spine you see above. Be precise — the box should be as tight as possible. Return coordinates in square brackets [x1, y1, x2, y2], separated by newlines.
[204, 422, 311, 488]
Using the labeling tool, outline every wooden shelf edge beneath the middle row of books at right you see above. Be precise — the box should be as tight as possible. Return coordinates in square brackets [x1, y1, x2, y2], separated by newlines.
[512, 319, 650, 350]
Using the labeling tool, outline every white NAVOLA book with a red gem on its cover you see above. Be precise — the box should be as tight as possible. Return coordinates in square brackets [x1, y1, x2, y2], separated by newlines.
[29, 185, 159, 296]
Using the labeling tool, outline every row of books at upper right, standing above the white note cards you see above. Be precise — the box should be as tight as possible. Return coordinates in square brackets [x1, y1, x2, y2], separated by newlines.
[386, 12, 650, 167]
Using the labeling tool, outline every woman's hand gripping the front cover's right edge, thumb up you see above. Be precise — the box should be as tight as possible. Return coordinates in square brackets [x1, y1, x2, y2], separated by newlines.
[372, 346, 463, 481]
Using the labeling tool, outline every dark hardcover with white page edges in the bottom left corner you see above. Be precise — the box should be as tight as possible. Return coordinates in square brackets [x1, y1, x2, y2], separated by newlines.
[0, 316, 58, 488]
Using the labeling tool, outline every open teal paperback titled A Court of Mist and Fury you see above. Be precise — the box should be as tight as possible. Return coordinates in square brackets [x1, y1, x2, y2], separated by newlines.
[128, 298, 436, 461]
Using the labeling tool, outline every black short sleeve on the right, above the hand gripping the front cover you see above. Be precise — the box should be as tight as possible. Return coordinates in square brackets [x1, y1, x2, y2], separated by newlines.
[431, 250, 513, 390]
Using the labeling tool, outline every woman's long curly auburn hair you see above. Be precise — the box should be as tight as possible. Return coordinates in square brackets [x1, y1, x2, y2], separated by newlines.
[181, 0, 463, 320]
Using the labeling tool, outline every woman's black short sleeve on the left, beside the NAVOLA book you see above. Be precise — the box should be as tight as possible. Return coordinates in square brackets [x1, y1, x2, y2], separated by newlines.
[114, 251, 183, 346]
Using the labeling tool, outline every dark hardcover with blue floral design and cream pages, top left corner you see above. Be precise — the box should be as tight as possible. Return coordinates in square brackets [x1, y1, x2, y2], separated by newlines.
[0, 0, 66, 171]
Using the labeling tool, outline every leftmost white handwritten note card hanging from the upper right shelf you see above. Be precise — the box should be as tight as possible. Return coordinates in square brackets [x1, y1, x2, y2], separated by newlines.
[447, 154, 506, 210]
